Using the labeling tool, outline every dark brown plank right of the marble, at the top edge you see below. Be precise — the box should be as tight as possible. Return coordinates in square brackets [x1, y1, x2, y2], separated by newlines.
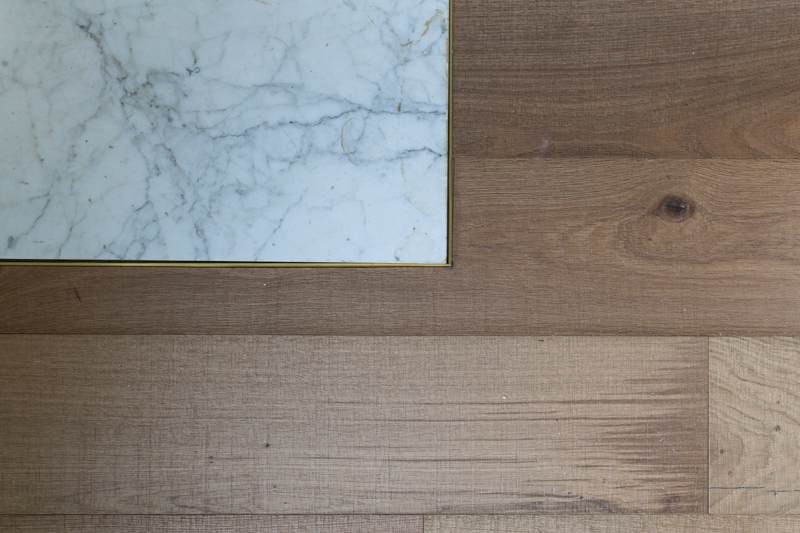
[453, 0, 800, 158]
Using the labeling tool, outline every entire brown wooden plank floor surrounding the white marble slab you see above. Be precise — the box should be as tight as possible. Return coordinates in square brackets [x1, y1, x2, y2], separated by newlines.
[0, 0, 800, 533]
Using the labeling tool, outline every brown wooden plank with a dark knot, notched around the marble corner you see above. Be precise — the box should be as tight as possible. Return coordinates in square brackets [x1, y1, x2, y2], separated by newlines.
[0, 158, 800, 335]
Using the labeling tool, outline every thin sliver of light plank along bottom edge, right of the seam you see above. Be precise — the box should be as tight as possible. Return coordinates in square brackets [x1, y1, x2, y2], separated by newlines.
[432, 515, 800, 533]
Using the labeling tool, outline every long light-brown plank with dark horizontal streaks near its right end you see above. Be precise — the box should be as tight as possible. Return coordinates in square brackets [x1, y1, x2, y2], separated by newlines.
[0, 335, 708, 514]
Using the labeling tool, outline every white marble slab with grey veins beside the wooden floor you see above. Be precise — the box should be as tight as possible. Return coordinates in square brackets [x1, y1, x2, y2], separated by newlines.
[0, 0, 449, 263]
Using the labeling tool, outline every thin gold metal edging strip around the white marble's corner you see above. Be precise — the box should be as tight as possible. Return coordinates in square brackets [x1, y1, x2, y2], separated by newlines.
[0, 10, 454, 268]
